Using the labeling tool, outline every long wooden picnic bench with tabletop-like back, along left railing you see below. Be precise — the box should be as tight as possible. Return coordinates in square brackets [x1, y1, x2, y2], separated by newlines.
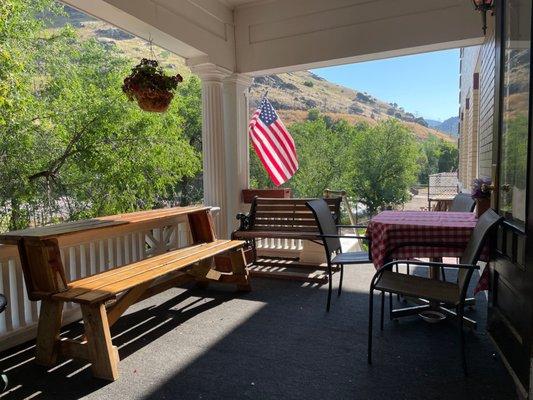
[0, 207, 250, 380]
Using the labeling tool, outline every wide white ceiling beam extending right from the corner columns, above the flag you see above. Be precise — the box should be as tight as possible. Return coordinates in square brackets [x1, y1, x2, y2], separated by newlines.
[234, 0, 482, 75]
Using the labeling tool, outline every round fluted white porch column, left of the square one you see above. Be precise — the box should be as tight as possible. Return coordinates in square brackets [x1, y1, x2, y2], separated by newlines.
[190, 63, 231, 238]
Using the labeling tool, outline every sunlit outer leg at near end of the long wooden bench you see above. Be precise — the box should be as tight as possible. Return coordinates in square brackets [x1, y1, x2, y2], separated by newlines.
[81, 303, 119, 381]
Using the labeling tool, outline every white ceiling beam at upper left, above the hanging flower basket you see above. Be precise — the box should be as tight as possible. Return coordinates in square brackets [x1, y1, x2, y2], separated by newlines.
[63, 0, 235, 71]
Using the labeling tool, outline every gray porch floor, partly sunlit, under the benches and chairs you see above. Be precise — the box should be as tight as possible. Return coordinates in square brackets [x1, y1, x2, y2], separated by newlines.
[0, 265, 516, 400]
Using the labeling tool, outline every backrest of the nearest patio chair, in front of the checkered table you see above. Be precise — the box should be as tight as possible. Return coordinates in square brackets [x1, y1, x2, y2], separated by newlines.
[458, 209, 503, 292]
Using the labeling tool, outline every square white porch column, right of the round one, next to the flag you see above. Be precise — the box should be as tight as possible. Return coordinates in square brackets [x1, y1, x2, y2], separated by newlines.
[224, 74, 252, 235]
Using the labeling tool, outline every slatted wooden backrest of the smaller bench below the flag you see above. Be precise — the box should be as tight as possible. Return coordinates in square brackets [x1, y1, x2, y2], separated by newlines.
[247, 197, 342, 233]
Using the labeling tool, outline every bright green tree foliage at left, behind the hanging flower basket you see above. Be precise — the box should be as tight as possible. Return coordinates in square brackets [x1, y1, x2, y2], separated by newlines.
[0, 0, 201, 229]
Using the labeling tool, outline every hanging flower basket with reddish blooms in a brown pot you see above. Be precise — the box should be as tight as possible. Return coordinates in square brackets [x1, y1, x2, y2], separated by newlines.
[122, 58, 183, 112]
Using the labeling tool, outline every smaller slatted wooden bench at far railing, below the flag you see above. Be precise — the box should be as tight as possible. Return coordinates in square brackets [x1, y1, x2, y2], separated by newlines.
[232, 197, 342, 283]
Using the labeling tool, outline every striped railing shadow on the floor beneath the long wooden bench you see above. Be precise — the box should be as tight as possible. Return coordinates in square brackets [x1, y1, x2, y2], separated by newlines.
[0, 282, 235, 400]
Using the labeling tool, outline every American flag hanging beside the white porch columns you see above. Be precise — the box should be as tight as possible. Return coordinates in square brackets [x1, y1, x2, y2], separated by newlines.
[249, 97, 298, 186]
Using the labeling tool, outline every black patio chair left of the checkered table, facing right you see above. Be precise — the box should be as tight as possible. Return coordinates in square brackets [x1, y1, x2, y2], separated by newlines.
[306, 199, 372, 311]
